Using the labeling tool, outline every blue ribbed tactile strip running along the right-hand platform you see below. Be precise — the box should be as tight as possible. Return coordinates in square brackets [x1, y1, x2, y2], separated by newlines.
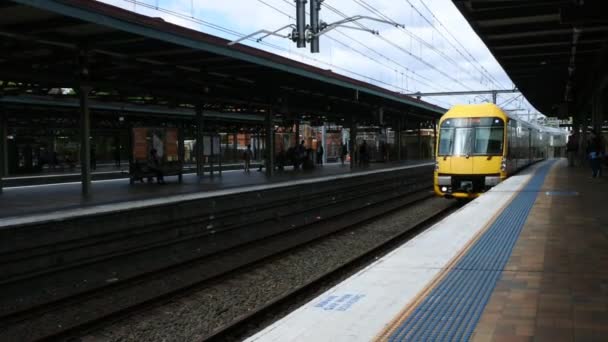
[389, 162, 553, 341]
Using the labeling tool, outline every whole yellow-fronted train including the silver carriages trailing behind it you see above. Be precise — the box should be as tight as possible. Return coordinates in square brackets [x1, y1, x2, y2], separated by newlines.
[434, 104, 567, 198]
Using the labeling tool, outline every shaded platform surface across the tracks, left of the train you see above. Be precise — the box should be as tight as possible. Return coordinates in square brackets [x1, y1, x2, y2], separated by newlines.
[0, 161, 432, 221]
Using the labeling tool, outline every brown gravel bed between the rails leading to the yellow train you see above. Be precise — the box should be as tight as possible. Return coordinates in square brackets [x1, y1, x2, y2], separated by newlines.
[83, 198, 453, 342]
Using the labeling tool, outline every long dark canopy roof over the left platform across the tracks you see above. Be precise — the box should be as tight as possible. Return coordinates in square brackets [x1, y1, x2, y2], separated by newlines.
[0, 0, 445, 122]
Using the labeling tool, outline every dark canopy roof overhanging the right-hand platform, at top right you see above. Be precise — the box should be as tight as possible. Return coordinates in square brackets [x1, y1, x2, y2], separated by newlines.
[453, 0, 608, 117]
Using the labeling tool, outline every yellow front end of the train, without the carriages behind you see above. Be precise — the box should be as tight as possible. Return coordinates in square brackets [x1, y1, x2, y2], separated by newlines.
[434, 110, 507, 199]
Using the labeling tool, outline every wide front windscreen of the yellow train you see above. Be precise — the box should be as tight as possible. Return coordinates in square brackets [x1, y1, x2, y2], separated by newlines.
[438, 117, 504, 156]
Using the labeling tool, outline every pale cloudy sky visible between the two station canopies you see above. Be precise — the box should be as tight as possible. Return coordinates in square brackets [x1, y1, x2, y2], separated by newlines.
[99, 0, 535, 113]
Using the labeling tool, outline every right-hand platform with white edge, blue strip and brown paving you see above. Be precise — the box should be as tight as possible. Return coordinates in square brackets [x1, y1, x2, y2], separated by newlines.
[247, 160, 608, 341]
